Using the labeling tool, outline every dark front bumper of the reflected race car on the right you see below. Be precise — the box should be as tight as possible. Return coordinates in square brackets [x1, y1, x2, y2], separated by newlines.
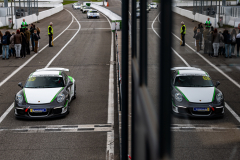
[172, 102, 225, 117]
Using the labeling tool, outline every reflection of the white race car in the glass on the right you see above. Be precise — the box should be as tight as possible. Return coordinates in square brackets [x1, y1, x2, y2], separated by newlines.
[171, 67, 225, 117]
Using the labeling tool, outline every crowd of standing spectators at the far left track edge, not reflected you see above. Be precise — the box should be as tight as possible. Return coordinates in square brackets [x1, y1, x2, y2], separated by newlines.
[0, 24, 40, 60]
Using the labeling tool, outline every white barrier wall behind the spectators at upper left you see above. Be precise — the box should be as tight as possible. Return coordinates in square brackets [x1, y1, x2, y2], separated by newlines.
[13, 4, 63, 29]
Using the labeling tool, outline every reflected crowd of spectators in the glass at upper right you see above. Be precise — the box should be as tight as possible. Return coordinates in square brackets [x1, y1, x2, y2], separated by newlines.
[193, 23, 240, 58]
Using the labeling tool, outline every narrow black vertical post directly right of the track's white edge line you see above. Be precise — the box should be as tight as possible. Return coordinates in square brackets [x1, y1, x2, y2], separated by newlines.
[121, 0, 129, 160]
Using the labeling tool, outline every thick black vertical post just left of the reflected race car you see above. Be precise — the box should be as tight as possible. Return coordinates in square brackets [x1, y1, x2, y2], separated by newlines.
[158, 0, 172, 159]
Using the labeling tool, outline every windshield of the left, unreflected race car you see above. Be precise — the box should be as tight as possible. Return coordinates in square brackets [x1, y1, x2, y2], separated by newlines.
[25, 76, 64, 88]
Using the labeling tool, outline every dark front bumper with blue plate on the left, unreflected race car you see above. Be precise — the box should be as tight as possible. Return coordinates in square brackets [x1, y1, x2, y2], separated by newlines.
[14, 103, 68, 119]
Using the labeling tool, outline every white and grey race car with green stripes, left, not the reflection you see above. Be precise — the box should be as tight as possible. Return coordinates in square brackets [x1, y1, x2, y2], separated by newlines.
[14, 68, 76, 119]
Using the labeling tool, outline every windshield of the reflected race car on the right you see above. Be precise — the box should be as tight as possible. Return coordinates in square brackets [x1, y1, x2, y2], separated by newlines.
[175, 76, 214, 87]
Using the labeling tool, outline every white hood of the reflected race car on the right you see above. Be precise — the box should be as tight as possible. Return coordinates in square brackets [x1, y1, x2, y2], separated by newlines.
[177, 87, 215, 103]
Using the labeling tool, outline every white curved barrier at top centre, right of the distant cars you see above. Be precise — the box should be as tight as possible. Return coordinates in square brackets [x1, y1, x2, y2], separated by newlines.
[91, 3, 122, 21]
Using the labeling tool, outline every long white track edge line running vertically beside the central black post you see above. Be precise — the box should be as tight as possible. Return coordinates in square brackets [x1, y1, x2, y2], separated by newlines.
[99, 13, 114, 160]
